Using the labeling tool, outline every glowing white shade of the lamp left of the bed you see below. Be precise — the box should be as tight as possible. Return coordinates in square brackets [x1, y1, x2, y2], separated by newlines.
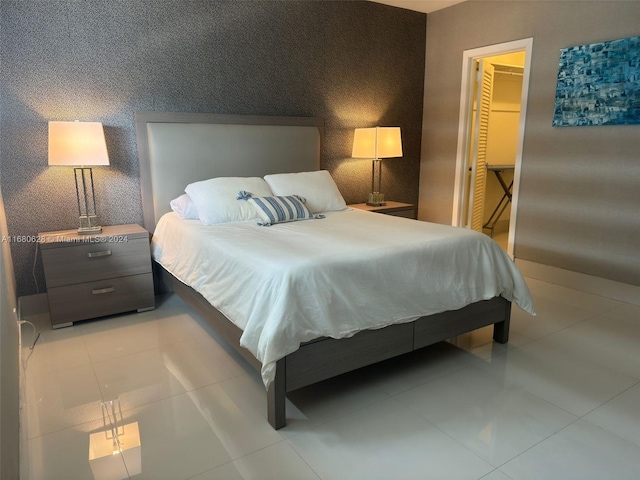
[49, 122, 109, 166]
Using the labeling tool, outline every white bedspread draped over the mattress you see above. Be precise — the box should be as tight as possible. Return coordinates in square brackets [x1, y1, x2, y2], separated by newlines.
[152, 210, 534, 386]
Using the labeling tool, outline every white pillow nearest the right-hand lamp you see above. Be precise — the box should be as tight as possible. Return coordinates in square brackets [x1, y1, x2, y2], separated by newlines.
[264, 170, 347, 213]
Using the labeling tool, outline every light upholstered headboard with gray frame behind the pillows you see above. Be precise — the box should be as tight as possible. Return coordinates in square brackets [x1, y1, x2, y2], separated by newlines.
[135, 112, 323, 232]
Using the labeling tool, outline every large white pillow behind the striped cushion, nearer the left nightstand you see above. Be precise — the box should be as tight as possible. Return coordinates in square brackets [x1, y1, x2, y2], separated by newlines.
[184, 177, 272, 225]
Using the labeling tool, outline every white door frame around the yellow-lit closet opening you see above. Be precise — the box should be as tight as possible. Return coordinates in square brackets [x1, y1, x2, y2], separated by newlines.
[451, 38, 533, 258]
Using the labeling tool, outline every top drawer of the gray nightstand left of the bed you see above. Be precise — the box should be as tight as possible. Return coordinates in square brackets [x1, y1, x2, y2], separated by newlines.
[42, 238, 151, 288]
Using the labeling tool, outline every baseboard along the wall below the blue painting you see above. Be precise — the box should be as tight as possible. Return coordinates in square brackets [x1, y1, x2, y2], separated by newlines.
[516, 258, 640, 306]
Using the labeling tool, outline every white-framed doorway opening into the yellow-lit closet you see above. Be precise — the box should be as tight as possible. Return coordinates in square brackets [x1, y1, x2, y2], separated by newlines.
[452, 39, 533, 258]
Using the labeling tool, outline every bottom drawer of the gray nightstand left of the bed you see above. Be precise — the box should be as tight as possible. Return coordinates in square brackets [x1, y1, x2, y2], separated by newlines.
[47, 273, 155, 325]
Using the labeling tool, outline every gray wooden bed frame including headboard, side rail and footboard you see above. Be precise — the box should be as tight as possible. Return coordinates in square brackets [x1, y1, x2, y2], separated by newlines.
[135, 112, 511, 429]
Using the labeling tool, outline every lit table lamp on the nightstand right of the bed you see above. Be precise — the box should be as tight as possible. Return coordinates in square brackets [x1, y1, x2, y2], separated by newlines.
[351, 127, 402, 207]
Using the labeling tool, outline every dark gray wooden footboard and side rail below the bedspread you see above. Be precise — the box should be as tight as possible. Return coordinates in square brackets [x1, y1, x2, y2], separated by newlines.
[156, 264, 511, 430]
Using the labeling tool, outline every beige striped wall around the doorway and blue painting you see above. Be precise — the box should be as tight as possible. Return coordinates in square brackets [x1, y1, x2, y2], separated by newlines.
[419, 0, 640, 285]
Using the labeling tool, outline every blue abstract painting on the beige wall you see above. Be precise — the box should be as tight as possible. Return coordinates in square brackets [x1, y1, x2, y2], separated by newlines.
[553, 37, 640, 127]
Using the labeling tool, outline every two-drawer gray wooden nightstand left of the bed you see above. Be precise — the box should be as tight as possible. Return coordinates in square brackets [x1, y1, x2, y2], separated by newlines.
[39, 225, 155, 328]
